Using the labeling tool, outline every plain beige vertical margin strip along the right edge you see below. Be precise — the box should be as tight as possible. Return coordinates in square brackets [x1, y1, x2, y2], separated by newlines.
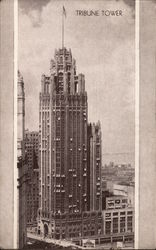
[139, 0, 156, 249]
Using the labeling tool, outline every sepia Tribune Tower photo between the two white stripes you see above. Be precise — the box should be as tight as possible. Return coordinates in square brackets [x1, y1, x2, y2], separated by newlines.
[17, 0, 135, 250]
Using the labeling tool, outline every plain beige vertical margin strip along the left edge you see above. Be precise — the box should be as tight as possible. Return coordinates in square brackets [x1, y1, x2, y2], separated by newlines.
[0, 0, 14, 249]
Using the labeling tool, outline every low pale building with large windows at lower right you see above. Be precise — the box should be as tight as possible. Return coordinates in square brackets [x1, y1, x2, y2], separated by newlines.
[102, 196, 134, 242]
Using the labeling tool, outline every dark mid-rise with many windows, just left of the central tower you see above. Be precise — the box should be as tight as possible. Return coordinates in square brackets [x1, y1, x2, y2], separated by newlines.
[25, 130, 39, 226]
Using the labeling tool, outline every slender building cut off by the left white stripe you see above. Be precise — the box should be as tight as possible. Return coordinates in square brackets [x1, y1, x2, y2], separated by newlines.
[17, 71, 27, 248]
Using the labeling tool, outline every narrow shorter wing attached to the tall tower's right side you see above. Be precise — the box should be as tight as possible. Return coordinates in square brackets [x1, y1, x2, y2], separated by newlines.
[87, 122, 102, 211]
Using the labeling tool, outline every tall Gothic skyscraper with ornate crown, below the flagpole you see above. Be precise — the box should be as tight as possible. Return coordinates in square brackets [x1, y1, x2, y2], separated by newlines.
[38, 48, 102, 239]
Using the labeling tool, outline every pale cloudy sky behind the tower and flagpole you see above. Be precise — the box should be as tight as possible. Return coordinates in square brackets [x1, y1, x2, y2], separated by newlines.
[18, 0, 135, 165]
